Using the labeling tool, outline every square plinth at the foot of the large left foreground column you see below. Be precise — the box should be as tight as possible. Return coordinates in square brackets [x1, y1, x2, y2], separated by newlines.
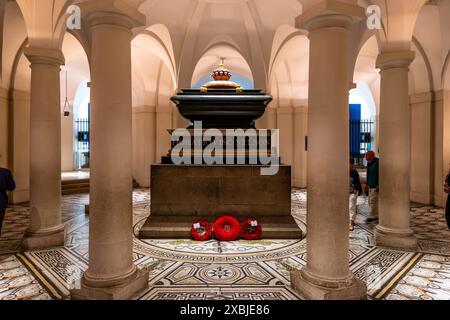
[70, 269, 149, 300]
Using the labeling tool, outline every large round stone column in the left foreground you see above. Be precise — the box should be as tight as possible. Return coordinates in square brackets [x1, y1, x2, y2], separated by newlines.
[72, 1, 148, 300]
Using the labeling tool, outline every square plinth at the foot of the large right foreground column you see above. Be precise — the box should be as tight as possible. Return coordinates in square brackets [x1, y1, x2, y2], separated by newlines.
[291, 270, 367, 300]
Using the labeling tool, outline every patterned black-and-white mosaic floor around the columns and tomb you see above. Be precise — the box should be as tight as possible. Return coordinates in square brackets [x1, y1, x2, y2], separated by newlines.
[0, 189, 450, 300]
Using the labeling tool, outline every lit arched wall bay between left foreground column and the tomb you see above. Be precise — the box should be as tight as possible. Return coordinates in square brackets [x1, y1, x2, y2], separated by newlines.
[131, 25, 178, 187]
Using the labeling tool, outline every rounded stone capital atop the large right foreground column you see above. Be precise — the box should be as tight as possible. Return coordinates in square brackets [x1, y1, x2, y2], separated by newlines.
[296, 0, 366, 32]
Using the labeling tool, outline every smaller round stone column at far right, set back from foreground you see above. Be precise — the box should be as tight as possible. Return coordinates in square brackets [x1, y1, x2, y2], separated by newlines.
[375, 51, 417, 250]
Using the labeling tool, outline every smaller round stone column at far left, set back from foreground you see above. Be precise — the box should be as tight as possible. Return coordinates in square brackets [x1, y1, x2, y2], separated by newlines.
[23, 48, 65, 250]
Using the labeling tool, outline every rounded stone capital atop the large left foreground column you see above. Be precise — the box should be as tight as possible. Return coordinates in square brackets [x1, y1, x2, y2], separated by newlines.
[79, 0, 147, 29]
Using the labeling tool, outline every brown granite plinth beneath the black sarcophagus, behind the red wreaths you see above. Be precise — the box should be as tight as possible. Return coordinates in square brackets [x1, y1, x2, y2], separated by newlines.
[140, 165, 302, 239]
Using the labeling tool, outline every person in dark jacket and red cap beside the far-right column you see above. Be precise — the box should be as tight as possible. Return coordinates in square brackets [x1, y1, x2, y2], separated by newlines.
[366, 151, 380, 223]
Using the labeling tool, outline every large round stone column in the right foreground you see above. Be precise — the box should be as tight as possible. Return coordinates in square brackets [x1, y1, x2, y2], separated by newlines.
[291, 2, 367, 300]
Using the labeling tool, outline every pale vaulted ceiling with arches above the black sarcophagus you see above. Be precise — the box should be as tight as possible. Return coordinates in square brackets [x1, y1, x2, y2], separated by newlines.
[0, 0, 450, 110]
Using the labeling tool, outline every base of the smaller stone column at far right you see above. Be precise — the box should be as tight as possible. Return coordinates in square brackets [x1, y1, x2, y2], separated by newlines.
[375, 225, 417, 251]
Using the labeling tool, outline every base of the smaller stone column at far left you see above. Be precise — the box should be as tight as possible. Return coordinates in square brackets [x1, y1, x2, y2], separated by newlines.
[22, 225, 66, 251]
